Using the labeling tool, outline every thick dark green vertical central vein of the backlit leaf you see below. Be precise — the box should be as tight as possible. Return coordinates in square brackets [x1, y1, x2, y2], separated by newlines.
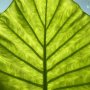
[43, 0, 47, 90]
